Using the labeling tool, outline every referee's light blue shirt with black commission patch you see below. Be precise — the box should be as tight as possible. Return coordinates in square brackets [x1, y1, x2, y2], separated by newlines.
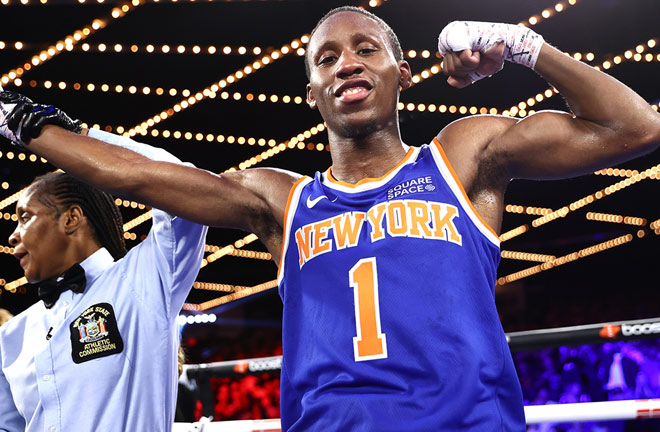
[0, 130, 207, 432]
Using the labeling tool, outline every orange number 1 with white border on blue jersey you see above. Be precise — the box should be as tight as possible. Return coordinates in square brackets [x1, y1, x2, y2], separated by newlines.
[348, 257, 387, 361]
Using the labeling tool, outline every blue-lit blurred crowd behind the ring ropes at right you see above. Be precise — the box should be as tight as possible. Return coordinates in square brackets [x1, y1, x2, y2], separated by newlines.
[513, 339, 660, 432]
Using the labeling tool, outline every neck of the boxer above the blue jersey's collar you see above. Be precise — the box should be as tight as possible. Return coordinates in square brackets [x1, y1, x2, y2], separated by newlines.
[329, 126, 406, 184]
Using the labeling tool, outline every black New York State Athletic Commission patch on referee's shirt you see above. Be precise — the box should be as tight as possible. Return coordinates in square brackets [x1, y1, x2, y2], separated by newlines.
[70, 303, 124, 363]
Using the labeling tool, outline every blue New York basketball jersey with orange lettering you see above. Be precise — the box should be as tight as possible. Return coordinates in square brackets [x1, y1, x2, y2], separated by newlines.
[278, 141, 525, 432]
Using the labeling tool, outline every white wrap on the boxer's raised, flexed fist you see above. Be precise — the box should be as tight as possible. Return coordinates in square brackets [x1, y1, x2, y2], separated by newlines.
[438, 21, 544, 82]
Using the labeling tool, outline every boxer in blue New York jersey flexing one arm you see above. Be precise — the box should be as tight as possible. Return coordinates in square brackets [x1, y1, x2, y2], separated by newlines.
[0, 7, 660, 431]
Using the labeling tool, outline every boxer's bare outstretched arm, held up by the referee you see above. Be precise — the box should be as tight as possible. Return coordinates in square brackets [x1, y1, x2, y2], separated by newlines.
[27, 125, 298, 254]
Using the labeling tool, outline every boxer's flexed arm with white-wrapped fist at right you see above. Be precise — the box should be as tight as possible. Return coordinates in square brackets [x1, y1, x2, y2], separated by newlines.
[440, 22, 660, 179]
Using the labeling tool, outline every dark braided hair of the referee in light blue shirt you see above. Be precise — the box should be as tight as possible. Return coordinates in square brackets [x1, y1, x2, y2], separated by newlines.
[30, 171, 126, 260]
